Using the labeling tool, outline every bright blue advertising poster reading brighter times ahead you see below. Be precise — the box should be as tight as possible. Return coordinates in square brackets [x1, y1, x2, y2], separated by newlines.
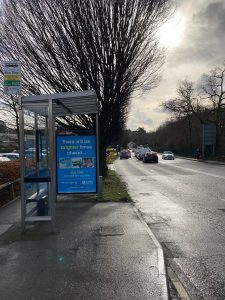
[57, 135, 97, 194]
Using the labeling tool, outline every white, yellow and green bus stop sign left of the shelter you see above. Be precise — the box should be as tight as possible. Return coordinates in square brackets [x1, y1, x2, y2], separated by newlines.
[3, 60, 21, 95]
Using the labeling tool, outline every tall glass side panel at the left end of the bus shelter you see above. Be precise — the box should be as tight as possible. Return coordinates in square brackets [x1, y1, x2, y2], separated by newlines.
[24, 106, 51, 221]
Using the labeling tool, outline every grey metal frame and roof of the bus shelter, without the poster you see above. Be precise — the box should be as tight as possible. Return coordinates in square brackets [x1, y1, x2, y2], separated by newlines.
[19, 90, 100, 231]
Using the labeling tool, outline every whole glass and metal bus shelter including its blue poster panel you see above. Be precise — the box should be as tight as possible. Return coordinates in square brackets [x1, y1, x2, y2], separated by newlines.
[19, 91, 100, 230]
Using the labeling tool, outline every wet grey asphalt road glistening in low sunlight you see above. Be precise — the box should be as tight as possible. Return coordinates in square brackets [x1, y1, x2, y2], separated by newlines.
[114, 157, 225, 300]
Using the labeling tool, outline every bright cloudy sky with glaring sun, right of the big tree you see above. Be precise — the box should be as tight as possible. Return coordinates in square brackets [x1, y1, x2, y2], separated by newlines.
[127, 0, 225, 131]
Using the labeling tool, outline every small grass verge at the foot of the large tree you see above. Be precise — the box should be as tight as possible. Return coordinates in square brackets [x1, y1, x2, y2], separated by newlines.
[102, 170, 131, 202]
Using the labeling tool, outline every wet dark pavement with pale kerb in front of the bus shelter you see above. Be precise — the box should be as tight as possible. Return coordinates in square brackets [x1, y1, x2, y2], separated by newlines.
[0, 199, 168, 300]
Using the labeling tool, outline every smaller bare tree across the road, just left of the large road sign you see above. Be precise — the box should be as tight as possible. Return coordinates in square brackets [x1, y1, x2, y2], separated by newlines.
[161, 80, 198, 147]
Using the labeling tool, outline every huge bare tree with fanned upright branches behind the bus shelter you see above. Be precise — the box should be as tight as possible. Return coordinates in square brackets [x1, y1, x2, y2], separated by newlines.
[0, 0, 170, 173]
